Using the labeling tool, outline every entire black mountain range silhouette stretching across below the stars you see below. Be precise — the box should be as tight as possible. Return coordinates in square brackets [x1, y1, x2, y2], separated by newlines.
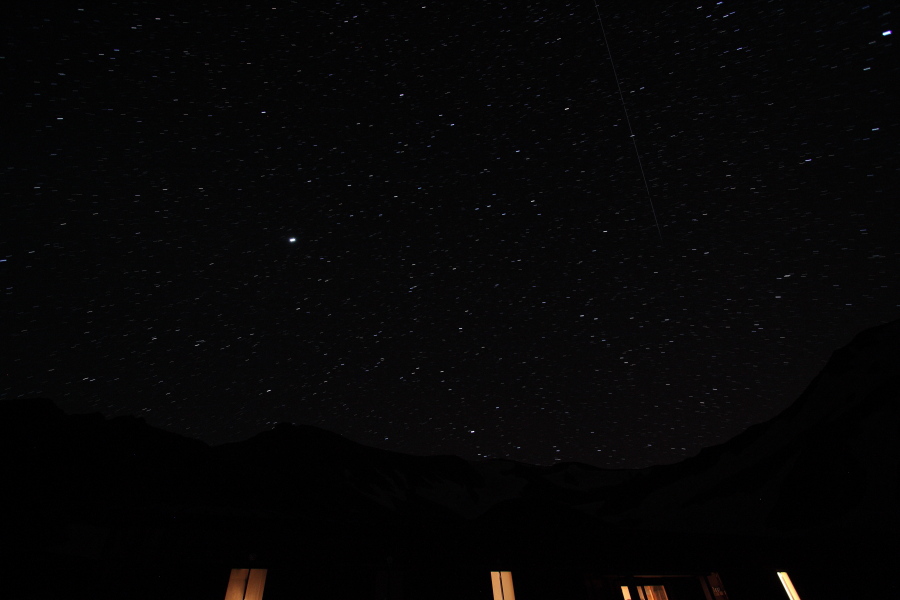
[0, 321, 900, 597]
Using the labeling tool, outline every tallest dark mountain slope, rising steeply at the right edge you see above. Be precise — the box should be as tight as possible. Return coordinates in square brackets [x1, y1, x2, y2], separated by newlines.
[605, 321, 900, 535]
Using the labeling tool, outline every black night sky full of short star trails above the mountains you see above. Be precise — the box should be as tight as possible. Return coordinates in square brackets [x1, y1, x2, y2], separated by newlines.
[0, 0, 900, 467]
